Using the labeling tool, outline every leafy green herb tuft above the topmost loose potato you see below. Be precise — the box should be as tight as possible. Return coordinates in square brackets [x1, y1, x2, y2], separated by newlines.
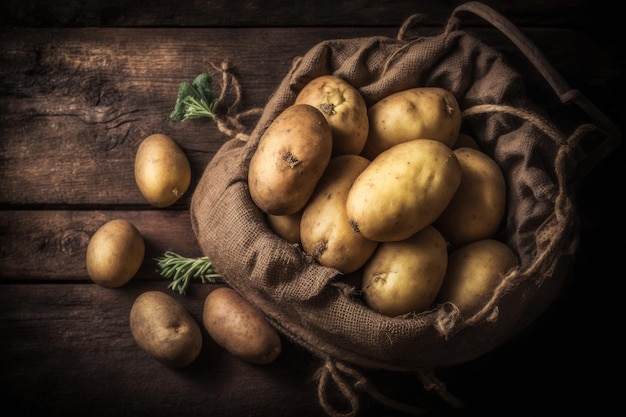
[170, 72, 219, 122]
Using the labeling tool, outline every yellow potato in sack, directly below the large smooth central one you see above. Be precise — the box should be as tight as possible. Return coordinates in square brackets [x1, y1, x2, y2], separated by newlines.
[362, 226, 448, 317]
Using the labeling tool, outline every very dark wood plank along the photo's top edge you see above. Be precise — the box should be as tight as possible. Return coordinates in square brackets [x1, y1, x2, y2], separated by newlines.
[0, 0, 608, 27]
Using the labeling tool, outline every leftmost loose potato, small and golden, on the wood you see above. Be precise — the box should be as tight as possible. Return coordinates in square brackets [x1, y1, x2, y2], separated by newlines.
[85, 219, 146, 288]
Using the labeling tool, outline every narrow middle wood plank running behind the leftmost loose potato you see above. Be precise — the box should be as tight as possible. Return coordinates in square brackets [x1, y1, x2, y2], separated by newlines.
[0, 210, 202, 281]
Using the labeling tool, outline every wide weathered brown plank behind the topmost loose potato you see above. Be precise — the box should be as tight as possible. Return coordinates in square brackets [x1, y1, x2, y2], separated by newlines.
[0, 28, 625, 207]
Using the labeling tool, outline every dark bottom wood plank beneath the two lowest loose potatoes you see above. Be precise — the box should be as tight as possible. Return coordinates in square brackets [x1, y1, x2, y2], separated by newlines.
[0, 284, 334, 417]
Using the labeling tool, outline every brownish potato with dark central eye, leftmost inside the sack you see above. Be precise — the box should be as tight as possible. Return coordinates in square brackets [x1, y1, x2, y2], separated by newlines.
[248, 104, 333, 215]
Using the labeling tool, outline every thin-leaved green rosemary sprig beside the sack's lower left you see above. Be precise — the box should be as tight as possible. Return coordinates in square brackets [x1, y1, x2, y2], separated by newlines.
[156, 251, 223, 295]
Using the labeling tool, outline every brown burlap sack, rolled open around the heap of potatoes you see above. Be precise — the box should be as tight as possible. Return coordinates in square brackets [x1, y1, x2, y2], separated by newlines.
[191, 4, 620, 414]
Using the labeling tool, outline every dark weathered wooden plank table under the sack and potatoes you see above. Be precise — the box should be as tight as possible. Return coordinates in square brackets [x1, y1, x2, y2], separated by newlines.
[0, 0, 626, 417]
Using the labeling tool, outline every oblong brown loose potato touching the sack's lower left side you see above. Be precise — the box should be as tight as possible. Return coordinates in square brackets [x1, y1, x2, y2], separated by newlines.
[202, 287, 282, 365]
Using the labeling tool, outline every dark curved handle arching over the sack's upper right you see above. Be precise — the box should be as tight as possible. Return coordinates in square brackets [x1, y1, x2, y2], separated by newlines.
[446, 1, 622, 181]
